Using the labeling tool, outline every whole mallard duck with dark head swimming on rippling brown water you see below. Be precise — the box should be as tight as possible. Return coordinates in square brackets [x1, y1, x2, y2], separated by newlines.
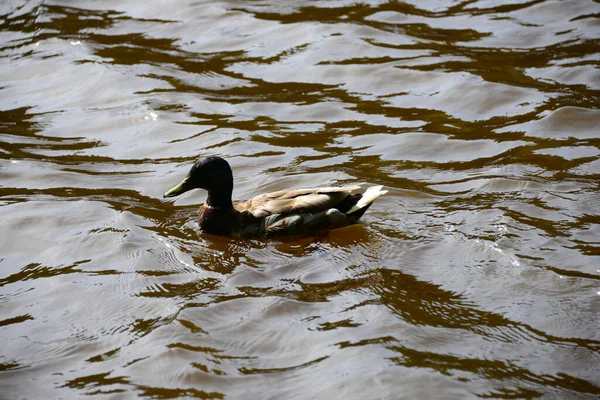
[164, 156, 387, 237]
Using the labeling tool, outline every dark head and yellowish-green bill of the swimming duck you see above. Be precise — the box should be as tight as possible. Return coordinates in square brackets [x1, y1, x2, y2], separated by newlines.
[163, 156, 233, 197]
